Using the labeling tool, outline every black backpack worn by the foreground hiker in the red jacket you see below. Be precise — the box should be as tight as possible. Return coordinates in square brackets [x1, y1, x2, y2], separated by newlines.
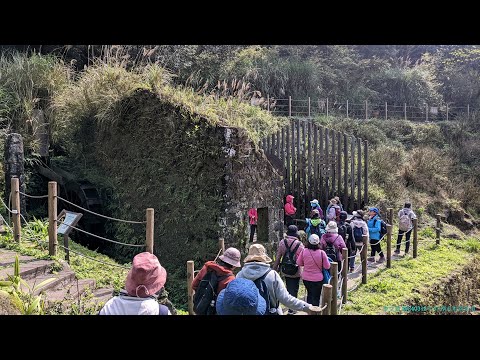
[193, 270, 230, 315]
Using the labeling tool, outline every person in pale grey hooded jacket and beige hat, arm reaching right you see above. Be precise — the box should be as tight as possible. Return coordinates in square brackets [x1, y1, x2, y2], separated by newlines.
[237, 244, 312, 315]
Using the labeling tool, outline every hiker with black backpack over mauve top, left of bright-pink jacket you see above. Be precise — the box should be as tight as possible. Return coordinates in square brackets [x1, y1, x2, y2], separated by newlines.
[273, 225, 305, 313]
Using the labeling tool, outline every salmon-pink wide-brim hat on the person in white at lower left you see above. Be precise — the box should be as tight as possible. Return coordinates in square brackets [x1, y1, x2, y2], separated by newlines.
[125, 252, 167, 297]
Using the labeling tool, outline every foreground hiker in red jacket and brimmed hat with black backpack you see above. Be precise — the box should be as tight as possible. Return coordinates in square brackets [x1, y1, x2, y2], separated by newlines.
[192, 247, 242, 315]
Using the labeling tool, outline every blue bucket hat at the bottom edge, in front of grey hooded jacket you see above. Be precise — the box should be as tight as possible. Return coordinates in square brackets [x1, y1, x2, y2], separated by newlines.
[216, 278, 267, 315]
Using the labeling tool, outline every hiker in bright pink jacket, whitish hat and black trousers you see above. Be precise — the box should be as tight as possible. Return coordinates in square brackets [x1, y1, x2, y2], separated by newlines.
[297, 234, 330, 306]
